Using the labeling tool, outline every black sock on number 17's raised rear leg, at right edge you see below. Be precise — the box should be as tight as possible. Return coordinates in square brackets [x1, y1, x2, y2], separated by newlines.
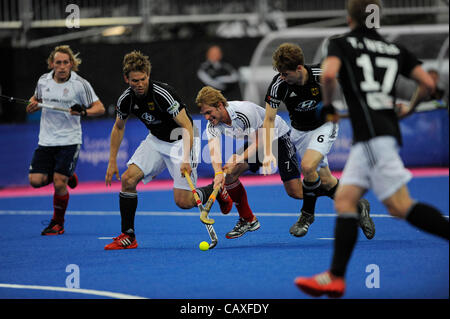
[406, 203, 450, 240]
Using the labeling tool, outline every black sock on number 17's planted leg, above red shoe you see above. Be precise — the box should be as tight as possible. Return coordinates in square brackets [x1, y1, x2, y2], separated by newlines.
[330, 213, 359, 277]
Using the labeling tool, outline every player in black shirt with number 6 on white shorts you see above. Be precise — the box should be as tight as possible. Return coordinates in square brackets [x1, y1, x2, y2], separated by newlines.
[264, 43, 375, 239]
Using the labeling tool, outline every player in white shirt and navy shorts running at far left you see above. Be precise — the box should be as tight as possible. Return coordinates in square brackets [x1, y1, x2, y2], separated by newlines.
[26, 45, 105, 235]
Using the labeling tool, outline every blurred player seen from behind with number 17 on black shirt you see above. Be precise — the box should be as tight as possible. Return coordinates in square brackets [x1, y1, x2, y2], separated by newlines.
[295, 0, 450, 297]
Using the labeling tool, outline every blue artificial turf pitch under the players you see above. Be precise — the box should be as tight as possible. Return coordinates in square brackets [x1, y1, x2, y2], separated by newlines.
[0, 177, 449, 299]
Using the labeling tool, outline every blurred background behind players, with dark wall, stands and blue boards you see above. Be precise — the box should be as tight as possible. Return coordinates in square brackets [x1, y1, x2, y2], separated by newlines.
[0, 0, 449, 187]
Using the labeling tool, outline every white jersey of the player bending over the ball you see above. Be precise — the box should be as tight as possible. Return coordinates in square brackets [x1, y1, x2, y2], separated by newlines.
[206, 101, 290, 140]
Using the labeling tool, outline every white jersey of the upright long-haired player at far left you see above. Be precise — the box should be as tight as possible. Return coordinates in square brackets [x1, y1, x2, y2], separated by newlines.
[34, 71, 98, 146]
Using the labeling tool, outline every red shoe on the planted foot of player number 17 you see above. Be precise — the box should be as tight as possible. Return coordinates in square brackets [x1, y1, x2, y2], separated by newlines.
[294, 271, 345, 298]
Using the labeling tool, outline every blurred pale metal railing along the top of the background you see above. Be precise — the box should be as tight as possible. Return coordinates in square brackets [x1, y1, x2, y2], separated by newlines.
[0, 0, 448, 29]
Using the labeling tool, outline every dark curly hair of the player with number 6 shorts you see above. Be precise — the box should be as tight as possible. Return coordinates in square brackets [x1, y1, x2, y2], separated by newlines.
[272, 43, 305, 72]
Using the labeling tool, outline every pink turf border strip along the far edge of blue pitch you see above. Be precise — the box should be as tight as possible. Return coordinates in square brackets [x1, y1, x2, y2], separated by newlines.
[0, 167, 449, 198]
